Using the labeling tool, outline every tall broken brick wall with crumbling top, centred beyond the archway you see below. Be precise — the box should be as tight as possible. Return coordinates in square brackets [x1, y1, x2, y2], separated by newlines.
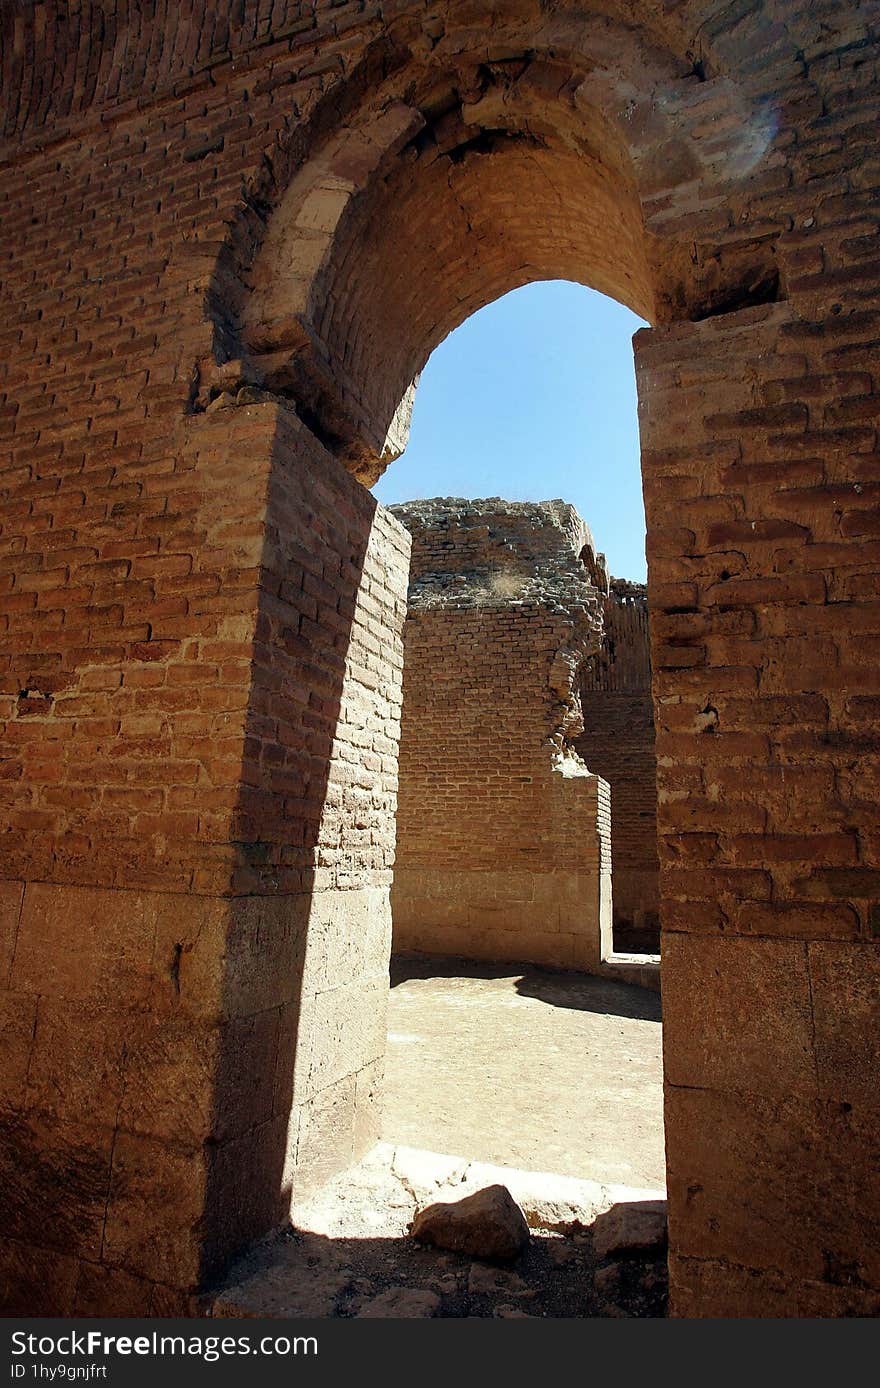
[391, 498, 611, 967]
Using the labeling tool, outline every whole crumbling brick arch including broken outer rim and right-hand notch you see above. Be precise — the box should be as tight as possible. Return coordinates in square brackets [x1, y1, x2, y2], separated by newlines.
[201, 19, 780, 484]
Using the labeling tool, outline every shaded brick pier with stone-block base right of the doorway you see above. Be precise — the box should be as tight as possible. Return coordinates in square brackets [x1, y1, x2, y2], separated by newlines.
[636, 303, 880, 1316]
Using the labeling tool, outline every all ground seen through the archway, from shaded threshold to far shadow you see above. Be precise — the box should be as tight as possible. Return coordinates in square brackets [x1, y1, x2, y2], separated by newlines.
[208, 956, 666, 1319]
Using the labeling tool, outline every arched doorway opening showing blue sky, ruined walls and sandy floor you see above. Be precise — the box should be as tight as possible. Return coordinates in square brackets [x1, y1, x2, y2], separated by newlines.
[375, 282, 665, 1192]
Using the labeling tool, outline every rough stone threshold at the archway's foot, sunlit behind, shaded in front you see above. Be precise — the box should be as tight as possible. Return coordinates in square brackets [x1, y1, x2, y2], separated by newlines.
[208, 1144, 666, 1319]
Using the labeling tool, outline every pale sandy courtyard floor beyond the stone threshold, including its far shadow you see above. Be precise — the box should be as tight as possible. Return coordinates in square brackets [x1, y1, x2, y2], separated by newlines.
[383, 955, 666, 1187]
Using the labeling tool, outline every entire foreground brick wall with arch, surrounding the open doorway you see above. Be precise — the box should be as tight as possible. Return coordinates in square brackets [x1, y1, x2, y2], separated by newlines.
[0, 0, 880, 1316]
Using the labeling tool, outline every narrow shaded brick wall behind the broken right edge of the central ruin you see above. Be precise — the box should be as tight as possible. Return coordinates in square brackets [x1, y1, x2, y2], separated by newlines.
[575, 579, 659, 954]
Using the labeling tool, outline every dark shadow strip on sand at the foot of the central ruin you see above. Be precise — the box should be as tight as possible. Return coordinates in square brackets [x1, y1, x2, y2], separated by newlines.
[390, 954, 662, 1022]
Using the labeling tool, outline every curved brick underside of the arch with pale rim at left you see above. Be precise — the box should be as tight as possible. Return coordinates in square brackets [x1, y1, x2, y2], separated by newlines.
[243, 81, 654, 484]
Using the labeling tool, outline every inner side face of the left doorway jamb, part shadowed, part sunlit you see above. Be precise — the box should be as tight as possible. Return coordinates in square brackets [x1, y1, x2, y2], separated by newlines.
[198, 414, 399, 1287]
